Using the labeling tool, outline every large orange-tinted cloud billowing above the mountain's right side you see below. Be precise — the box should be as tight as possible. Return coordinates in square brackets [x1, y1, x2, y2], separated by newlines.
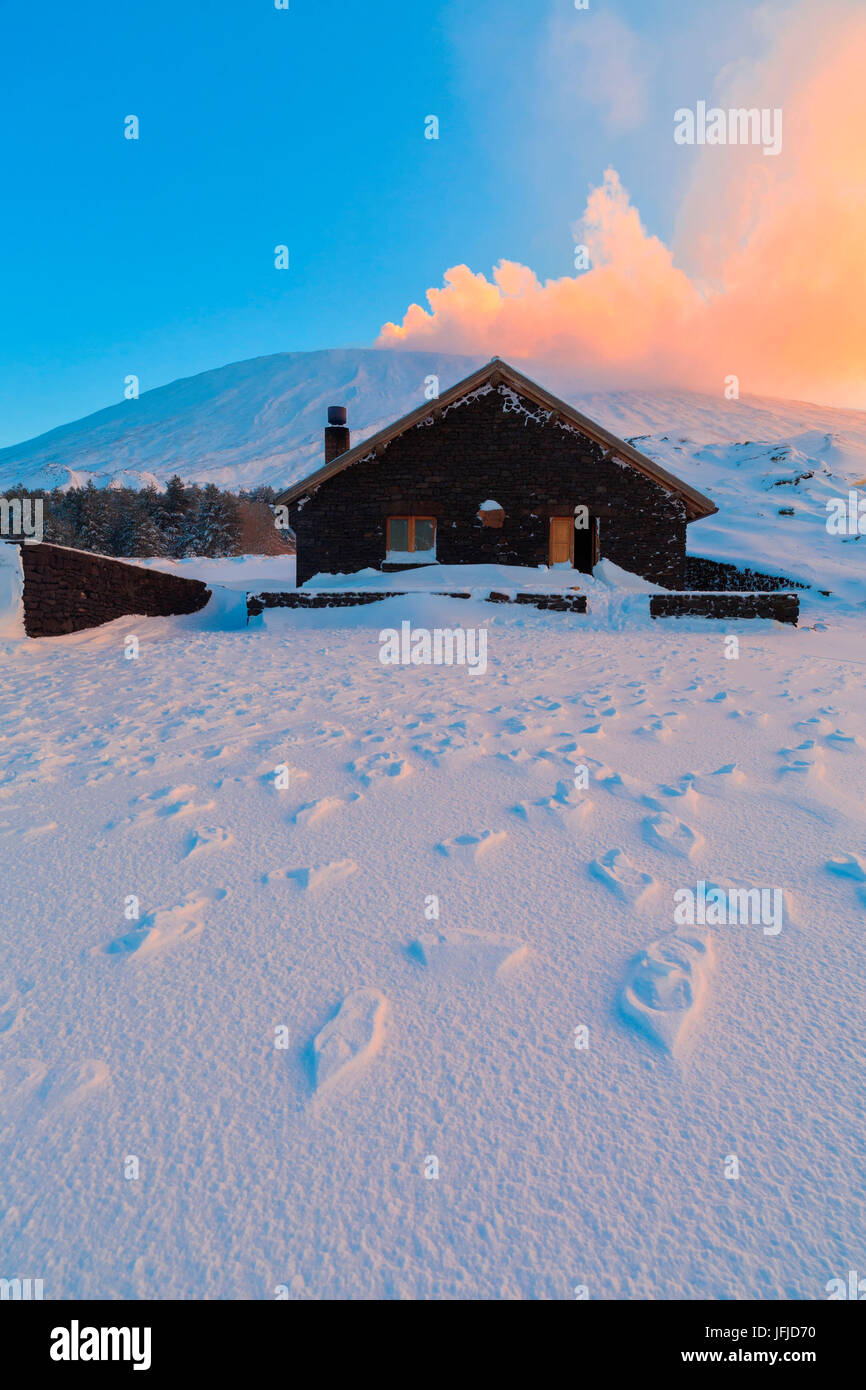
[379, 0, 866, 406]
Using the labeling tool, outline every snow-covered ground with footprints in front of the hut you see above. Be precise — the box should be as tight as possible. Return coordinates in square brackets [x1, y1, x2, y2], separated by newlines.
[0, 548, 866, 1300]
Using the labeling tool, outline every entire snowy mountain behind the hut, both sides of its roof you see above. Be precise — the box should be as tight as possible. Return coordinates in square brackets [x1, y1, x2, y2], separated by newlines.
[0, 349, 866, 602]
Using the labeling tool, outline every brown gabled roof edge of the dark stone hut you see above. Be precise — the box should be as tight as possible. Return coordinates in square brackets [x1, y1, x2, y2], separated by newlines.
[277, 357, 719, 521]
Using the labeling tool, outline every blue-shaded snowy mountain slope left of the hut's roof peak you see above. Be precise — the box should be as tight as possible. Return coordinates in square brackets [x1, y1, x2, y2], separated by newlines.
[0, 349, 489, 488]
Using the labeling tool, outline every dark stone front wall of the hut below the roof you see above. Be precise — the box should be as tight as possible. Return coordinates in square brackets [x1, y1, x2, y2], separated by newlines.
[289, 386, 685, 588]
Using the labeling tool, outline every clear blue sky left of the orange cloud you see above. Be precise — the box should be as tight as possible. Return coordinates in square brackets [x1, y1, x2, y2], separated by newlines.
[0, 0, 772, 446]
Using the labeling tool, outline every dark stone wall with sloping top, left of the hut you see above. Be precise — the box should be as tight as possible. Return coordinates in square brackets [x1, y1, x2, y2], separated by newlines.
[21, 543, 210, 637]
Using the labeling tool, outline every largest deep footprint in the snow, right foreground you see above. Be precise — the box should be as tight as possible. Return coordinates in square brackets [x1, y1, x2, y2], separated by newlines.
[620, 927, 713, 1054]
